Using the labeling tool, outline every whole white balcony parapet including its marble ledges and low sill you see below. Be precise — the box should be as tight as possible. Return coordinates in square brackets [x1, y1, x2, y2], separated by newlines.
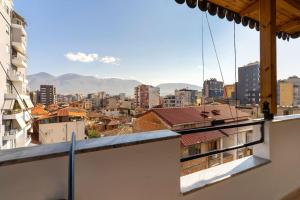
[0, 115, 300, 200]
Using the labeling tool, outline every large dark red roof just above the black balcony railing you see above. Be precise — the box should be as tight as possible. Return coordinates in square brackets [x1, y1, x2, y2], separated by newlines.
[149, 104, 249, 126]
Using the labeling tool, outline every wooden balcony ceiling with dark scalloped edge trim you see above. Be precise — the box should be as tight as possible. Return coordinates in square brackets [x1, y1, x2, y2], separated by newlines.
[175, 0, 300, 40]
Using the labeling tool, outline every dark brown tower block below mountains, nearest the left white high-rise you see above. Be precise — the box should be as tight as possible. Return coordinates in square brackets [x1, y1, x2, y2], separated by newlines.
[39, 85, 57, 106]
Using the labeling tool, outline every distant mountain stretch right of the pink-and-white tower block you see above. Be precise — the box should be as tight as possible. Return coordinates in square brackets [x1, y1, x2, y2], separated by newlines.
[157, 83, 201, 96]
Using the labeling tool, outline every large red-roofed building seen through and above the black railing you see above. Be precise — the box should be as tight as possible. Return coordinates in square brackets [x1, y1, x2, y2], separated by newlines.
[133, 104, 252, 175]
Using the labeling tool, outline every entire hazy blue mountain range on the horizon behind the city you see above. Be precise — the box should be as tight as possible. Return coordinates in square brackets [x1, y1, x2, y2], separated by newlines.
[27, 72, 201, 96]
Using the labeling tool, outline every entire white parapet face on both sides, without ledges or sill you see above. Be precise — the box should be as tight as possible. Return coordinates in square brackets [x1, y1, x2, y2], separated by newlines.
[0, 119, 300, 200]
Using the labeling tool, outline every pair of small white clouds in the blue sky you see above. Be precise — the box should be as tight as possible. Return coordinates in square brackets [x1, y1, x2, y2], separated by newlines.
[65, 52, 120, 65]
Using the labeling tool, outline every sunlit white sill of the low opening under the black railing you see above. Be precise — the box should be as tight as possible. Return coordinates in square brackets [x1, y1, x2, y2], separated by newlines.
[180, 156, 270, 195]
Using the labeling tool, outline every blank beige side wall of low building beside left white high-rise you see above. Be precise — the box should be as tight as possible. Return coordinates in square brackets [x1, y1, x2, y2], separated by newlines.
[39, 121, 86, 144]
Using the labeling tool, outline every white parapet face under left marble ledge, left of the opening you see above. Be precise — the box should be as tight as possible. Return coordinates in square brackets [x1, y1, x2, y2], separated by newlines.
[0, 132, 180, 200]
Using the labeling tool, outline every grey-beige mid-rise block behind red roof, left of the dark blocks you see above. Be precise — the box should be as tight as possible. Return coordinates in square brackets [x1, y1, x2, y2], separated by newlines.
[175, 89, 198, 107]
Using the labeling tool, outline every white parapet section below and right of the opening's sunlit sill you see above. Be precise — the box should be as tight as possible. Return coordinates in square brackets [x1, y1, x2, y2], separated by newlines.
[182, 119, 300, 200]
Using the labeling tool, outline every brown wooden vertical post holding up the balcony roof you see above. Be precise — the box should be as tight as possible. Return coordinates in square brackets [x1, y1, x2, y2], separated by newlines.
[259, 0, 277, 119]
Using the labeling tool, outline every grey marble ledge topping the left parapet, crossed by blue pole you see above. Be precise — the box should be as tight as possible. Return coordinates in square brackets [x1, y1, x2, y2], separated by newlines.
[0, 130, 180, 166]
